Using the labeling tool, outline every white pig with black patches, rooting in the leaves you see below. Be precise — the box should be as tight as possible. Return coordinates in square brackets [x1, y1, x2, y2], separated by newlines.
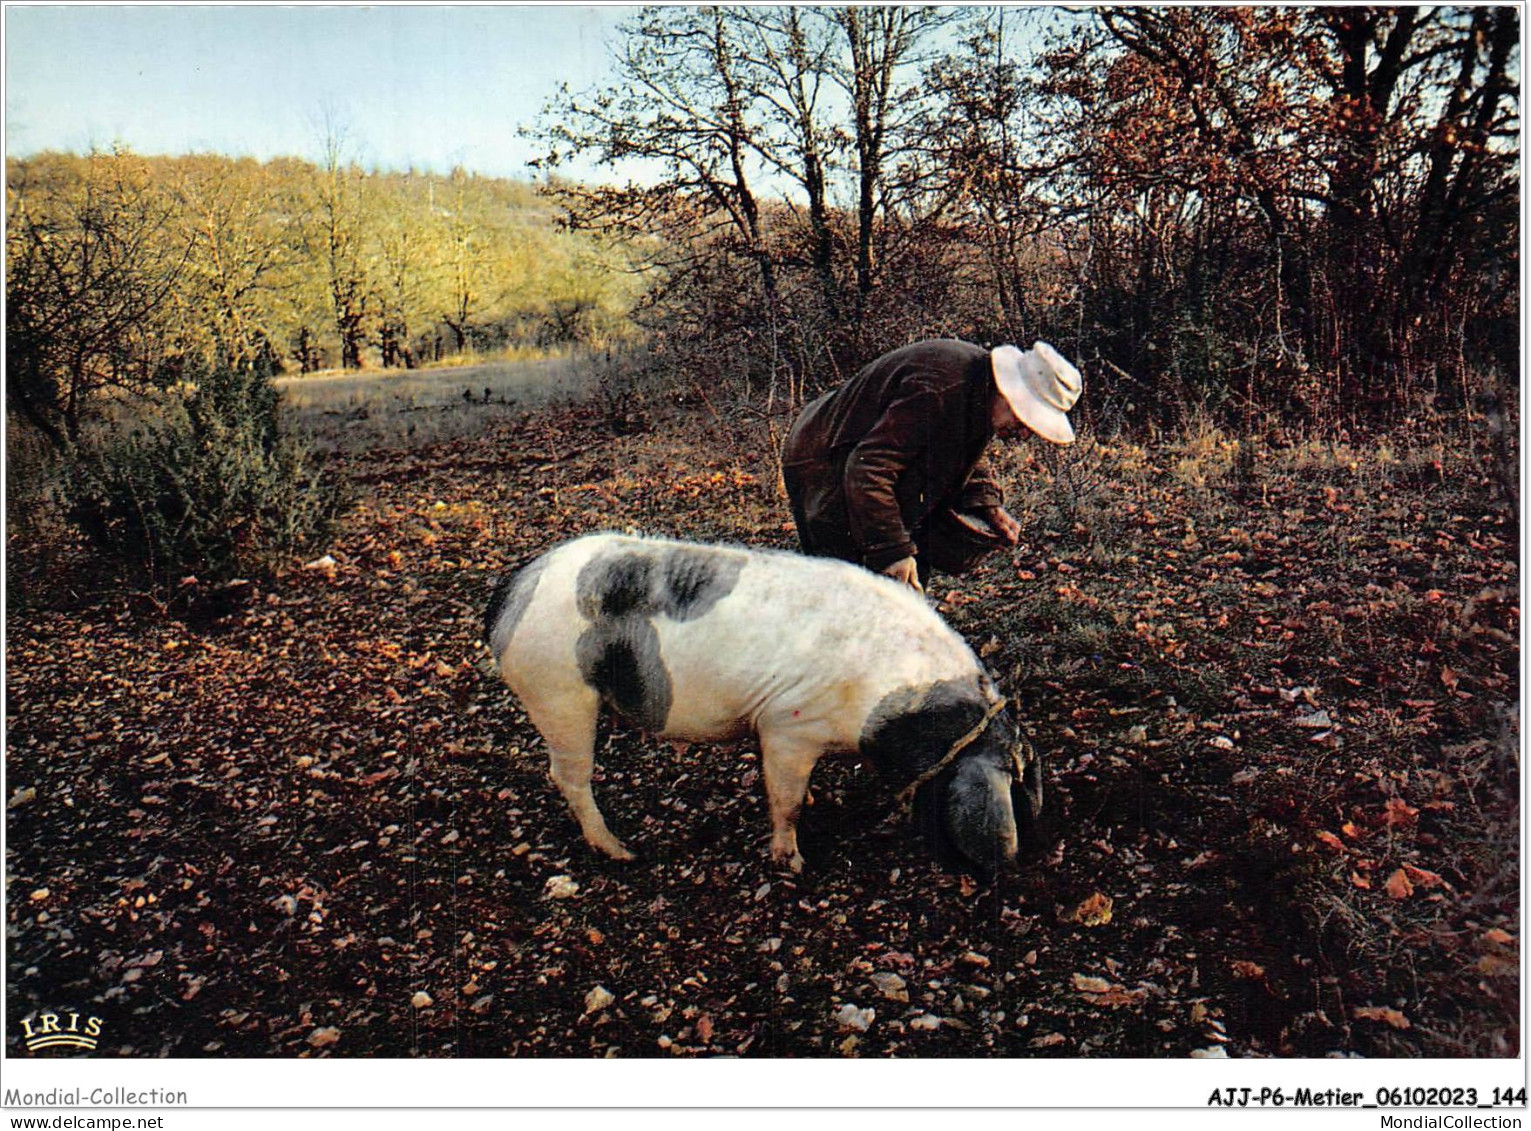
[484, 534, 1043, 874]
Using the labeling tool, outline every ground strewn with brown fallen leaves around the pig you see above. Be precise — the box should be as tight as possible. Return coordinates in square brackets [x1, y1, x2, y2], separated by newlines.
[6, 409, 1520, 1056]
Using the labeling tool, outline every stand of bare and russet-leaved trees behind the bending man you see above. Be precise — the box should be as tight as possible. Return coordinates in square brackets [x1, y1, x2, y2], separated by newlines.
[539, 6, 1520, 432]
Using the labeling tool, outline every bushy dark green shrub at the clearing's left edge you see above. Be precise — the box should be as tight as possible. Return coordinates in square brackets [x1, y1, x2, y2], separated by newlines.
[64, 366, 340, 589]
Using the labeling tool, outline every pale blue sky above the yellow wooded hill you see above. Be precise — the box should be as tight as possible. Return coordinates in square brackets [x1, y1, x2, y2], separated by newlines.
[5, 5, 635, 179]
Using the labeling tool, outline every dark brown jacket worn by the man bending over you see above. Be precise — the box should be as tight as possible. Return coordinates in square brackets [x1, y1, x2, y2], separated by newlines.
[782, 340, 1003, 569]
